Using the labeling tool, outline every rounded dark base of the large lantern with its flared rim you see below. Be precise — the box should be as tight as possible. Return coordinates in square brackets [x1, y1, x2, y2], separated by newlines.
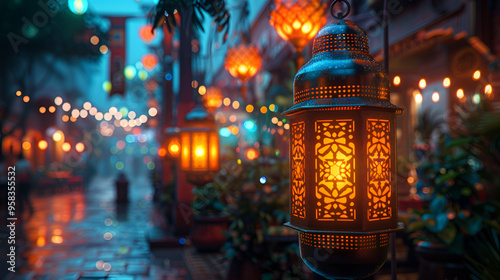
[285, 223, 403, 279]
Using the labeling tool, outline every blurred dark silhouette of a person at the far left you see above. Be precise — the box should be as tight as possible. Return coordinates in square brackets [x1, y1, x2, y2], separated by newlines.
[15, 153, 33, 219]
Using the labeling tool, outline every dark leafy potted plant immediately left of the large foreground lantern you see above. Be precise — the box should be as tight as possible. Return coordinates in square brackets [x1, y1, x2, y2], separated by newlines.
[225, 158, 302, 279]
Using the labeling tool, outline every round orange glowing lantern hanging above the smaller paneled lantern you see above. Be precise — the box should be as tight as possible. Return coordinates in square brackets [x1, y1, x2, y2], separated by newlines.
[225, 44, 262, 83]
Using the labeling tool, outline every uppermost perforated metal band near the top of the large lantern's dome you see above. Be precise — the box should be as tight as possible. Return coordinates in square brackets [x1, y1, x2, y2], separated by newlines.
[313, 33, 369, 55]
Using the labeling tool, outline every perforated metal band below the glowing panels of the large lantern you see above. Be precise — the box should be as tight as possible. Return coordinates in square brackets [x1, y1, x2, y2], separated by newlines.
[300, 232, 389, 250]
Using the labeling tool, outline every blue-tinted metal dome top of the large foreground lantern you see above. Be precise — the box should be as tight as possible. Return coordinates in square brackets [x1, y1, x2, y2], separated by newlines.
[285, 19, 401, 115]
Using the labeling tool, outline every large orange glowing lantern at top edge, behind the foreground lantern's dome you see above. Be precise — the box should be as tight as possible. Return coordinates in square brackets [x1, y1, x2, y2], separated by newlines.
[269, 0, 328, 52]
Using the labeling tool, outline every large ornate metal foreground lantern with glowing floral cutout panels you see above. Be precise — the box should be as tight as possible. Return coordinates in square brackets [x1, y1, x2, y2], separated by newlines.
[285, 1, 402, 279]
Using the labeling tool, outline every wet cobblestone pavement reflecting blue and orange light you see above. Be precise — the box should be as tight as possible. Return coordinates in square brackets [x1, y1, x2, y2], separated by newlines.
[6, 178, 191, 280]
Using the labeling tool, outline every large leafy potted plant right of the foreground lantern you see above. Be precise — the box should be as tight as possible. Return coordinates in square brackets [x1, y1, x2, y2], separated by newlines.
[407, 95, 500, 279]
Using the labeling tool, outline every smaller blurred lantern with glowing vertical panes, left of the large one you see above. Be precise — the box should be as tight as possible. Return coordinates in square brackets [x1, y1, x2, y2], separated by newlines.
[180, 107, 219, 186]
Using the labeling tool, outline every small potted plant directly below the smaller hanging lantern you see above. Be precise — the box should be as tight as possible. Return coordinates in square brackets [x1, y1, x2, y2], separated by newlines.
[191, 182, 229, 252]
